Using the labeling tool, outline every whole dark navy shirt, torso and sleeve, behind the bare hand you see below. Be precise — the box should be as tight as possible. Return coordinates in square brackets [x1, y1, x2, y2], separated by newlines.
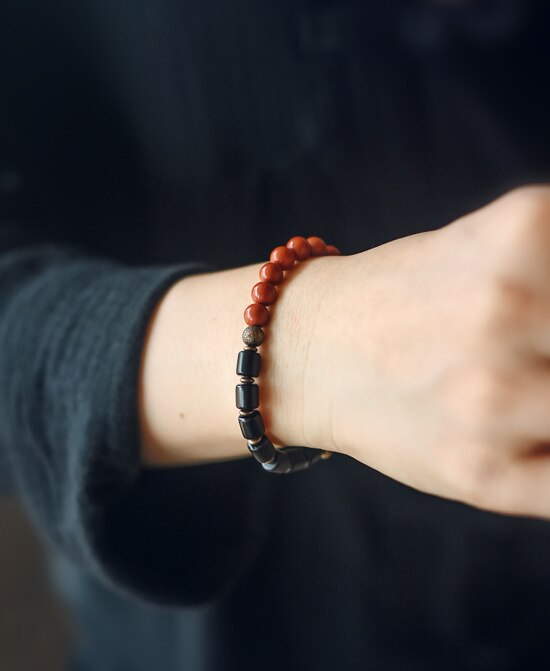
[0, 0, 550, 671]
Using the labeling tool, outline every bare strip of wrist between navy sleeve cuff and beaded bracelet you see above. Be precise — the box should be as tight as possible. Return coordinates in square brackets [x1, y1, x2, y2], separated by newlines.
[139, 264, 266, 465]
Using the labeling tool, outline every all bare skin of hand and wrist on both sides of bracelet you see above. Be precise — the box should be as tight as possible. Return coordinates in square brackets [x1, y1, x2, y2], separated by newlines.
[139, 186, 550, 518]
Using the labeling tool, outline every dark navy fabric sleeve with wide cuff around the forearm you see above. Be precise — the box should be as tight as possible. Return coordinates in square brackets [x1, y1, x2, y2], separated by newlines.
[0, 244, 274, 604]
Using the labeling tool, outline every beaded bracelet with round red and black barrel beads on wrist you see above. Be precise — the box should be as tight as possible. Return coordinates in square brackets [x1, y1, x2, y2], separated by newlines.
[235, 236, 340, 473]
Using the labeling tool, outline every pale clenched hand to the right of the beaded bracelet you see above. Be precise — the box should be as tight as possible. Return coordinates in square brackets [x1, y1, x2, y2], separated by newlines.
[298, 187, 550, 517]
